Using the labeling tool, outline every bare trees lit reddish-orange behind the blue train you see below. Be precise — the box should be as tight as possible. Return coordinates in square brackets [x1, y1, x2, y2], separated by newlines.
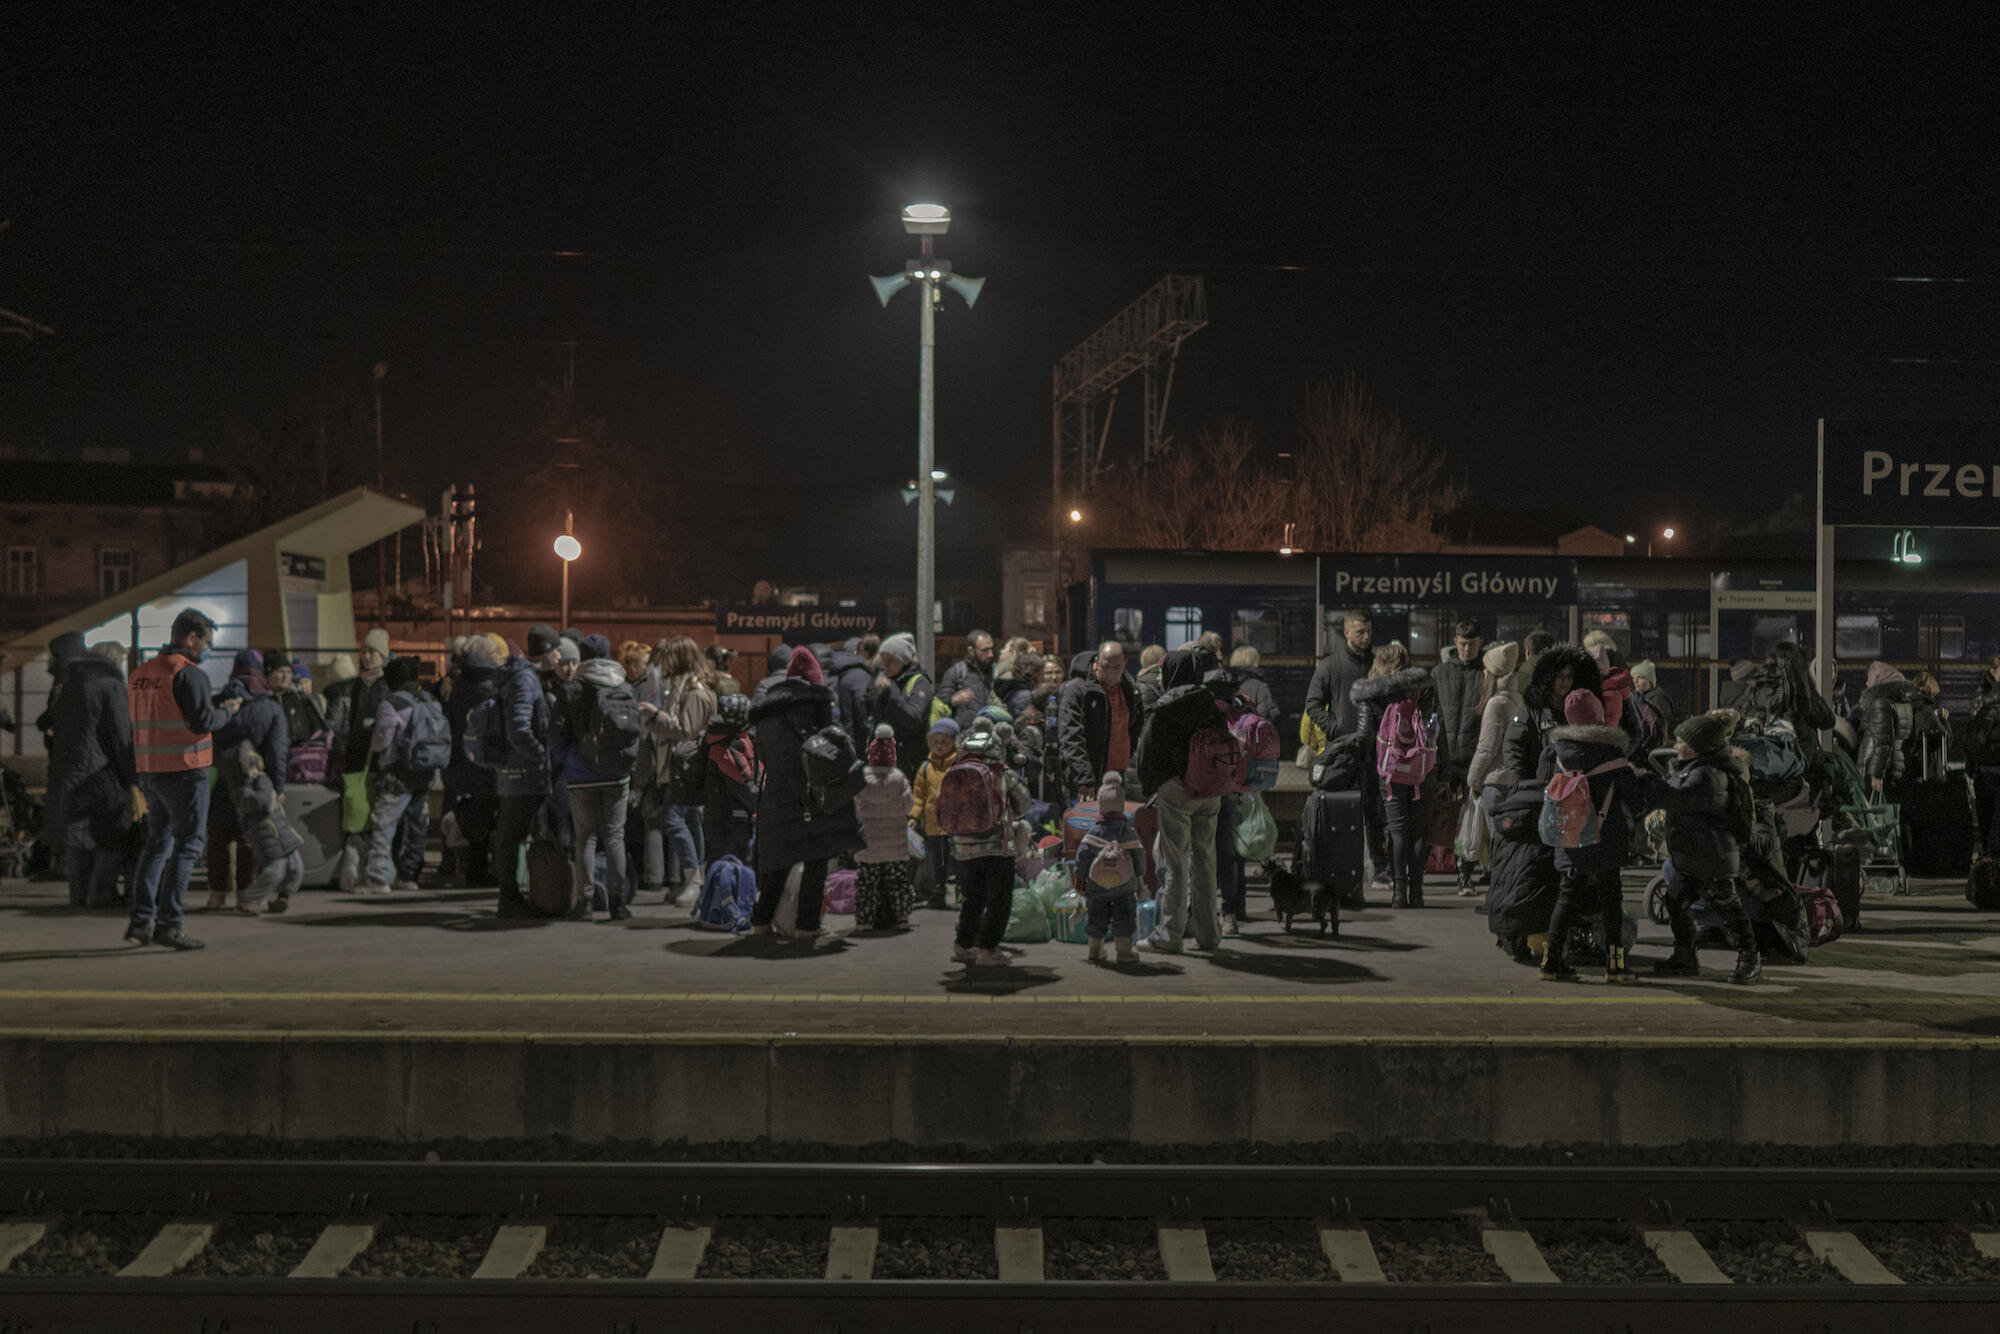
[1092, 374, 1460, 552]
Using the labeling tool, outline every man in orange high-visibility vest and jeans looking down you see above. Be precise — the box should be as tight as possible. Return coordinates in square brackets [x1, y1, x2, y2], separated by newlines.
[126, 608, 242, 950]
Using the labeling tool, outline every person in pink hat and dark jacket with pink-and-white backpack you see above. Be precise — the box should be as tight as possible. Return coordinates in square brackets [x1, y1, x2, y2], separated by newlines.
[1540, 690, 1640, 982]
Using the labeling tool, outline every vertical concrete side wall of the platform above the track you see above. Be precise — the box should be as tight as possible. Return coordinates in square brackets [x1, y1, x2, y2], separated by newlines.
[0, 1034, 2000, 1144]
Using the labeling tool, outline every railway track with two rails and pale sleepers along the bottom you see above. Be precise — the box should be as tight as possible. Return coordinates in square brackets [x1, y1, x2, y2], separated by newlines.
[0, 1160, 2000, 1334]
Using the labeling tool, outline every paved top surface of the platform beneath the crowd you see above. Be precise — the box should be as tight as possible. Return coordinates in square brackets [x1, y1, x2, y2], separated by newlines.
[0, 876, 2000, 1048]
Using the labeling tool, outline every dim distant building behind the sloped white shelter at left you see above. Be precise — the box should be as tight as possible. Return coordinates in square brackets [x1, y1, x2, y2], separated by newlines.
[0, 456, 230, 640]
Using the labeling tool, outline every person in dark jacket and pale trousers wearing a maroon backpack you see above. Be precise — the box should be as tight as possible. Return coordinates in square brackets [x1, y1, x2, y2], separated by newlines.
[1136, 644, 1236, 954]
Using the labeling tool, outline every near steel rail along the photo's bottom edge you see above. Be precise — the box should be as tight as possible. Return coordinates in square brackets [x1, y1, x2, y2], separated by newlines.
[0, 1278, 2000, 1334]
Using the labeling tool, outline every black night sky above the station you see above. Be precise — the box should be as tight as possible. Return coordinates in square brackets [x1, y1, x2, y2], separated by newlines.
[0, 4, 2000, 576]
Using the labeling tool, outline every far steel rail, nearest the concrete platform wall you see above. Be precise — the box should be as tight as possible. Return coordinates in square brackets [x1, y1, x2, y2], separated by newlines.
[11, 1160, 2000, 1226]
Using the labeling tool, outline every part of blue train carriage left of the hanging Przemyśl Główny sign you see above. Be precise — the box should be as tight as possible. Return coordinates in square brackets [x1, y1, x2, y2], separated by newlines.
[1090, 552, 1318, 746]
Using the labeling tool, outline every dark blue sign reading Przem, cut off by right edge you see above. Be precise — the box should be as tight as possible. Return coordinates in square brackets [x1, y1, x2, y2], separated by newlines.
[1820, 420, 2000, 528]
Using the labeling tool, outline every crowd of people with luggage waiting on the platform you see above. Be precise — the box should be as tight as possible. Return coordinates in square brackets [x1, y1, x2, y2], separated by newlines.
[42, 610, 2000, 982]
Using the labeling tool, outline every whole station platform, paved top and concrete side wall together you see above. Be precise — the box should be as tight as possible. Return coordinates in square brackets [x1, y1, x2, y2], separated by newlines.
[0, 880, 2000, 1144]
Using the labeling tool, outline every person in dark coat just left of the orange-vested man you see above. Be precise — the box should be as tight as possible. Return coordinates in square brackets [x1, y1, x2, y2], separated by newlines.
[48, 650, 138, 908]
